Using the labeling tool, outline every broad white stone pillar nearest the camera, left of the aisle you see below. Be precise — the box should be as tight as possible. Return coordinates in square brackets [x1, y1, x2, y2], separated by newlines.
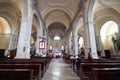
[15, 2, 33, 58]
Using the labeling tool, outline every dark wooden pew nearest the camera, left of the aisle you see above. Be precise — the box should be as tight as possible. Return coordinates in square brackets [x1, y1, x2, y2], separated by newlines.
[0, 69, 33, 80]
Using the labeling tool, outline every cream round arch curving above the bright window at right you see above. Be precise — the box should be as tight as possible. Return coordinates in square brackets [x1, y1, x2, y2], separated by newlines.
[94, 8, 120, 35]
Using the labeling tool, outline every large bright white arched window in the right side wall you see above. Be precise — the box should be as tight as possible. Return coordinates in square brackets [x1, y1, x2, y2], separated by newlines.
[100, 21, 119, 49]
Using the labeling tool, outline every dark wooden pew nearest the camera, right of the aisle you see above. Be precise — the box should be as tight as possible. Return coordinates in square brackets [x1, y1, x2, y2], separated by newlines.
[92, 68, 120, 80]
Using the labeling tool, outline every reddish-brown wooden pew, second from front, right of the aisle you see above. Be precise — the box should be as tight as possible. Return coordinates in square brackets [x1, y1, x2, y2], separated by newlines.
[80, 63, 120, 80]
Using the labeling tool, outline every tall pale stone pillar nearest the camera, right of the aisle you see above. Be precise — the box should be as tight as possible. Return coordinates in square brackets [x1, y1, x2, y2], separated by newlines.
[88, 0, 98, 59]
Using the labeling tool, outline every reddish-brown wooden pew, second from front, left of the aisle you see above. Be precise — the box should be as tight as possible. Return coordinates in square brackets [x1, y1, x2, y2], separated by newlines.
[0, 63, 41, 80]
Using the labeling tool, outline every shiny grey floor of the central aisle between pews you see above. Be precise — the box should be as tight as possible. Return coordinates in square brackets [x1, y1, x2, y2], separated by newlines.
[42, 59, 80, 80]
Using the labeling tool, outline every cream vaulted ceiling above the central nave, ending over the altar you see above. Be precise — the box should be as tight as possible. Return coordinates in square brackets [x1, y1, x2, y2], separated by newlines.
[38, 0, 79, 39]
